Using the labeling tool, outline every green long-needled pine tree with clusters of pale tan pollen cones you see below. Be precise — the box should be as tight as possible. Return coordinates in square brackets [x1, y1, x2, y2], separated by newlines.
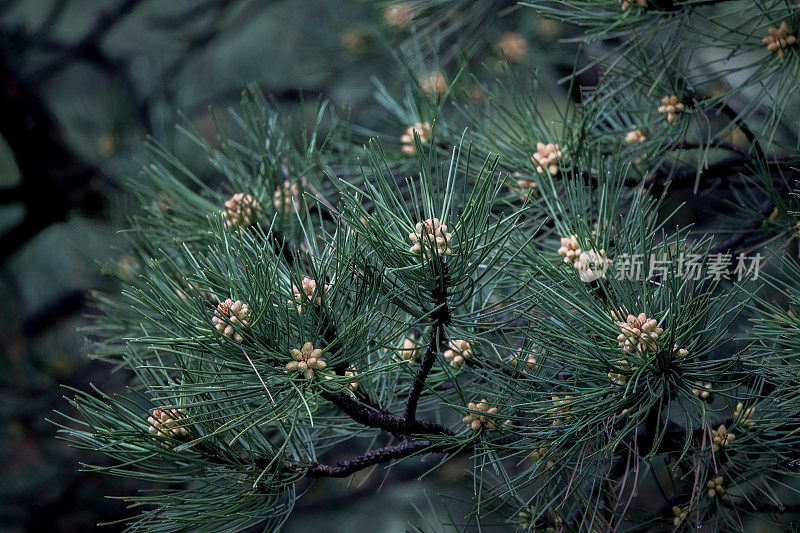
[64, 0, 800, 531]
